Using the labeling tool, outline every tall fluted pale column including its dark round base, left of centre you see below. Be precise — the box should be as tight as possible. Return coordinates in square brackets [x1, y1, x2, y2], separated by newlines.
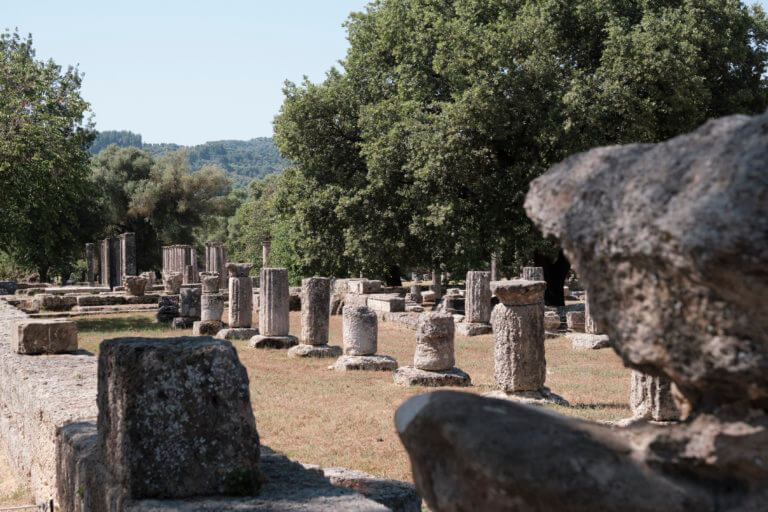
[248, 267, 299, 348]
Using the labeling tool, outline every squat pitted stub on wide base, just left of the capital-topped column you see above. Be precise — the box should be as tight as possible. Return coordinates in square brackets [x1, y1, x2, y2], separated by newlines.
[393, 312, 472, 387]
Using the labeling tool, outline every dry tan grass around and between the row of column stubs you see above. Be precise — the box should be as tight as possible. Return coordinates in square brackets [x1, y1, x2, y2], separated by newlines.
[70, 312, 630, 480]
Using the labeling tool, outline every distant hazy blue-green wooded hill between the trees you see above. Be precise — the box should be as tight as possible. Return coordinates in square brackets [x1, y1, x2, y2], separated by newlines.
[90, 130, 285, 188]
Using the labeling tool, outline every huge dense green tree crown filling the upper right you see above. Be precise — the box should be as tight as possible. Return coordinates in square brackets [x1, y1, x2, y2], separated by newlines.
[275, 0, 768, 275]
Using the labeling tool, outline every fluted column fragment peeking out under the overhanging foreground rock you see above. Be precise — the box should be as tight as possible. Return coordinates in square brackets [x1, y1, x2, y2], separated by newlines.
[629, 370, 680, 421]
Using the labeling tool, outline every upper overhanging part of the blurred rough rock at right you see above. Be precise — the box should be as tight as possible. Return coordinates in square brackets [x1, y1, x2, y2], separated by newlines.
[525, 110, 768, 407]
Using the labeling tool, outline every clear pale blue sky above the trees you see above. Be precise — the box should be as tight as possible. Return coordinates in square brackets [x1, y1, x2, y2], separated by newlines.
[6, 0, 768, 145]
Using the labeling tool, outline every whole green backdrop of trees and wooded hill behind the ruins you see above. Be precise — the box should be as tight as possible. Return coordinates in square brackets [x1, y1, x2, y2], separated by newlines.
[0, 0, 768, 303]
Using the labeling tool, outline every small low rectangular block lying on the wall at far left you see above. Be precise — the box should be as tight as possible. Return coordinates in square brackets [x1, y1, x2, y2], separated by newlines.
[11, 319, 77, 355]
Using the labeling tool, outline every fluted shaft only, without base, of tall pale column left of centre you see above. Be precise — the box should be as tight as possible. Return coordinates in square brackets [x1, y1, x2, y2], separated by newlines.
[259, 267, 290, 336]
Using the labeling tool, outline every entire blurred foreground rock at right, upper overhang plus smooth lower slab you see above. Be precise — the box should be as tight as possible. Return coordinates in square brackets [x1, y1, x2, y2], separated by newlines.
[395, 114, 768, 512]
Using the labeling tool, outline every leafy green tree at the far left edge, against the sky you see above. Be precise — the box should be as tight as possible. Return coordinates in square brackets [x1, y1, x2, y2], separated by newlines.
[0, 32, 93, 281]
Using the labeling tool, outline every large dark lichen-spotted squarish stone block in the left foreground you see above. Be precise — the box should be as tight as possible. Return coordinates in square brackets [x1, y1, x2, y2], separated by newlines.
[98, 337, 260, 499]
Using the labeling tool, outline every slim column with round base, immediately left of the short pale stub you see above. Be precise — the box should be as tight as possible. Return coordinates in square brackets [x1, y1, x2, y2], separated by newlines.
[288, 277, 341, 357]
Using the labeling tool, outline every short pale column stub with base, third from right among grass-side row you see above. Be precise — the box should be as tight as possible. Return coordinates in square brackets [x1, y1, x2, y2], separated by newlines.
[328, 306, 397, 371]
